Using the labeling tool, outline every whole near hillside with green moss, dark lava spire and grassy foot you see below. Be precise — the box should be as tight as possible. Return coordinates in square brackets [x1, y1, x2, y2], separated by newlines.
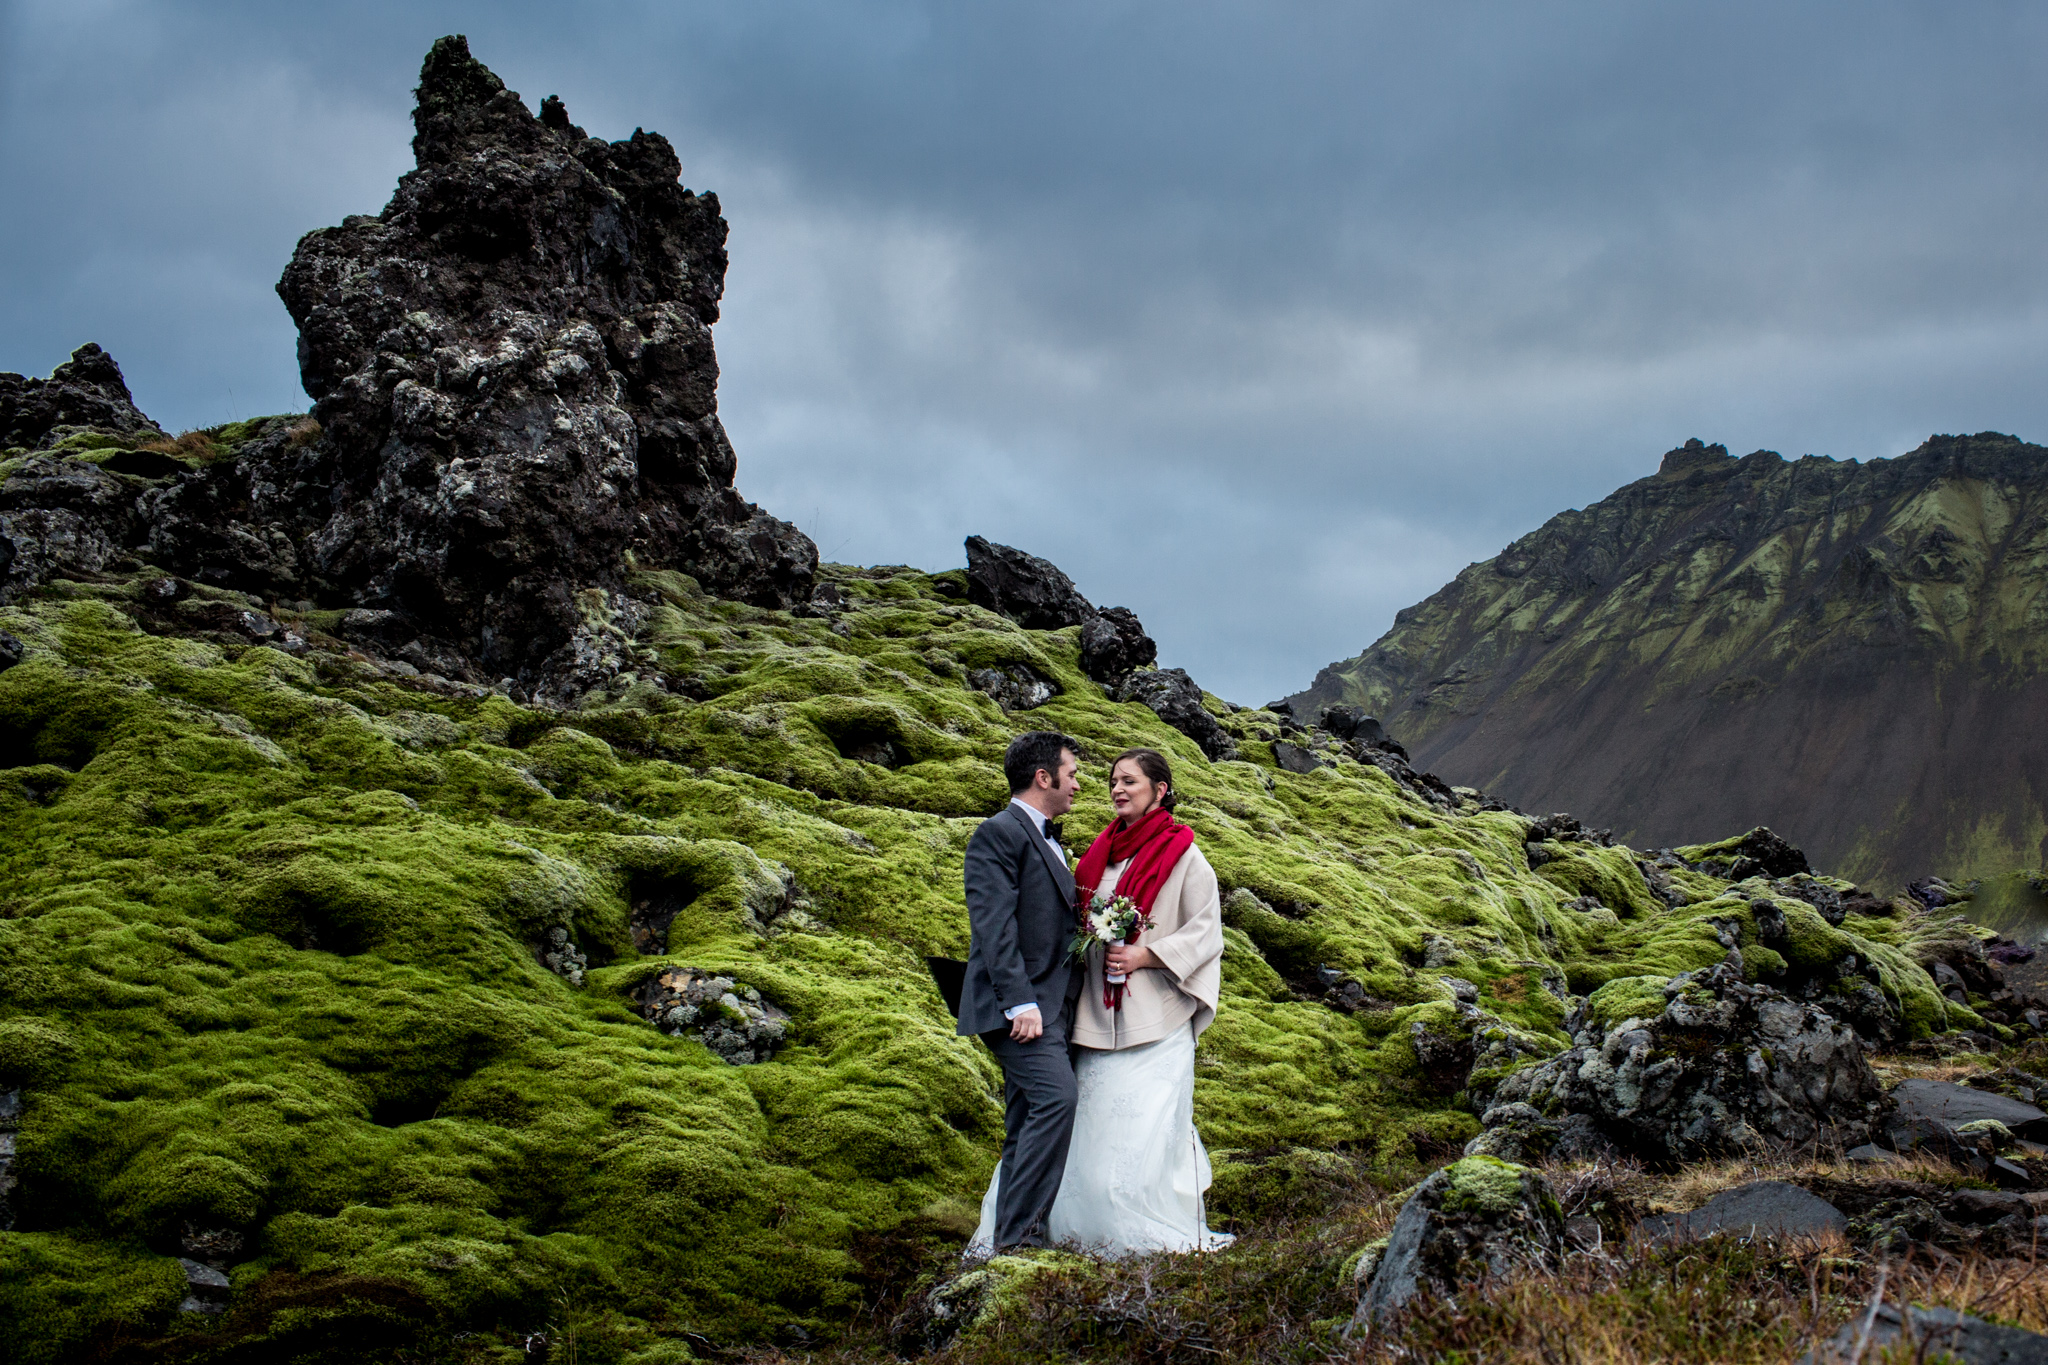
[0, 29, 2048, 1365]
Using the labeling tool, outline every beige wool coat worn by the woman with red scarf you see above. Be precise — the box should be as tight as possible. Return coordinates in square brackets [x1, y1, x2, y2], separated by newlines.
[1067, 843, 1223, 1050]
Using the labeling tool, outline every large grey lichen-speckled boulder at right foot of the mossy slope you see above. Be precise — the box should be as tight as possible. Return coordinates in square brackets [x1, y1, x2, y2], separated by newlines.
[1481, 952, 1882, 1164]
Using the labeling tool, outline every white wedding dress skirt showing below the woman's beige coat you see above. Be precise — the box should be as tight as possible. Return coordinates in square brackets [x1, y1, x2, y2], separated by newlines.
[967, 1023, 1237, 1257]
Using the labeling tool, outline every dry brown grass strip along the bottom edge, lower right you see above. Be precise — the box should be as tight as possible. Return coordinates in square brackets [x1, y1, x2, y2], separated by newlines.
[739, 1224, 2048, 1365]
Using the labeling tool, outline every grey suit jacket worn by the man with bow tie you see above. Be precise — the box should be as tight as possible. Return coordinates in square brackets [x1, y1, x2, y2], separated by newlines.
[961, 804, 1079, 1036]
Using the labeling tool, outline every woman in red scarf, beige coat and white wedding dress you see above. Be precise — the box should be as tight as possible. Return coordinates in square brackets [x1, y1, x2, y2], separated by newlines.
[969, 749, 1235, 1254]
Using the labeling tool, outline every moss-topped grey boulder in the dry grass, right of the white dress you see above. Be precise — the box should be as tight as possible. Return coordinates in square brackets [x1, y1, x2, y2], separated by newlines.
[1352, 1156, 1565, 1332]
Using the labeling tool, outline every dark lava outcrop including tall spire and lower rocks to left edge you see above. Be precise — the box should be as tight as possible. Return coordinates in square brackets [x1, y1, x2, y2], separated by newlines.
[0, 37, 817, 696]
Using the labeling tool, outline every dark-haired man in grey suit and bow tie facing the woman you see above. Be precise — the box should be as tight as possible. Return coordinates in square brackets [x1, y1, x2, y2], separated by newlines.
[961, 731, 1081, 1250]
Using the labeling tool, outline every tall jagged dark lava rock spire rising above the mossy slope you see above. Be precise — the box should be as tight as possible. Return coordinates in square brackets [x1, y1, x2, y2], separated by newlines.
[279, 37, 817, 675]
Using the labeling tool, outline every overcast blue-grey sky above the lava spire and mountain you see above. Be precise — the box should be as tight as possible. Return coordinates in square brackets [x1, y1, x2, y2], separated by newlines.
[0, 0, 2048, 702]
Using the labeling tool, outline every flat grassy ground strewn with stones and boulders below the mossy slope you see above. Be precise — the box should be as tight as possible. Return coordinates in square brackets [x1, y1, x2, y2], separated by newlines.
[733, 1046, 2048, 1365]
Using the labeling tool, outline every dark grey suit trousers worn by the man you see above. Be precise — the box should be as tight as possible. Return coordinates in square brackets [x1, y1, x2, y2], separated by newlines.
[981, 1019, 1075, 1250]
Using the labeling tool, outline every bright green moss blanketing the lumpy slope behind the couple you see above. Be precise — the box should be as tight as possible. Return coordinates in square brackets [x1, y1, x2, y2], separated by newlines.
[0, 540, 1976, 1361]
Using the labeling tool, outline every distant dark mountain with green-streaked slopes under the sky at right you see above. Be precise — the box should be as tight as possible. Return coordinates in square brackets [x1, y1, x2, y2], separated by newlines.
[1296, 432, 2048, 888]
